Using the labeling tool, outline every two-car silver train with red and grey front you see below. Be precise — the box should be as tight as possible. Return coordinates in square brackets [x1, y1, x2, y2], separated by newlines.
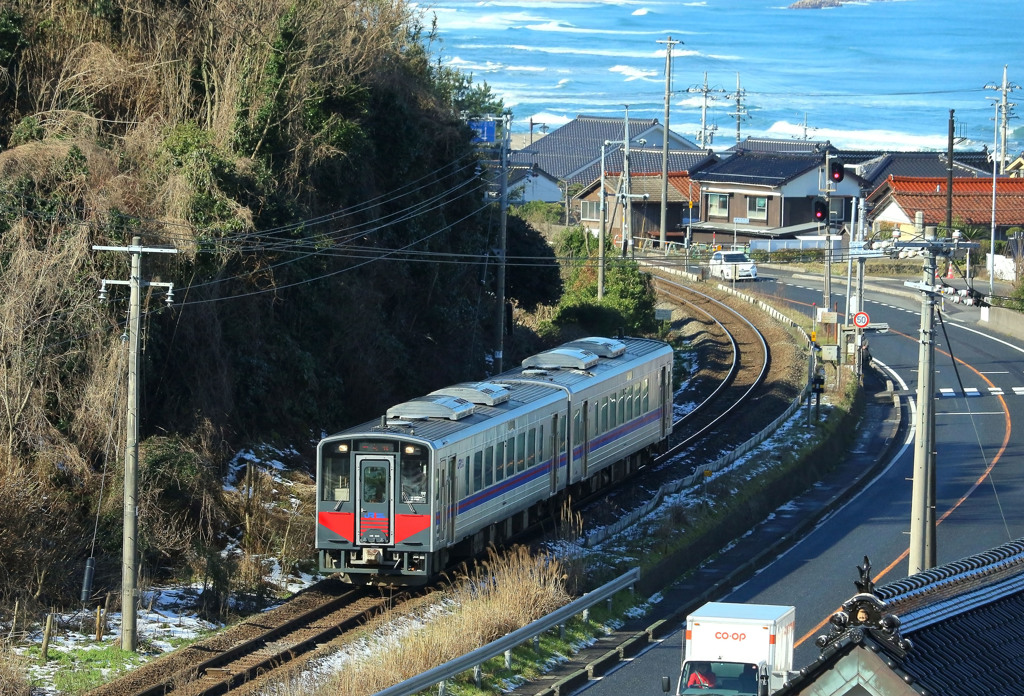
[316, 338, 673, 584]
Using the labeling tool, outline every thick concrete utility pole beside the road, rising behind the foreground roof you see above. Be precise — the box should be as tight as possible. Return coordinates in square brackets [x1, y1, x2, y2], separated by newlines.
[894, 212, 978, 575]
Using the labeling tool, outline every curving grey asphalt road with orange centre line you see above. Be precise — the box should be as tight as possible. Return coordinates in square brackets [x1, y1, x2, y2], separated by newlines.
[586, 272, 1024, 696]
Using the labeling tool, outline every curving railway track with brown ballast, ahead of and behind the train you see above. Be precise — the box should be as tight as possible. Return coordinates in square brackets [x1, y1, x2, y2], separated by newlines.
[83, 277, 794, 696]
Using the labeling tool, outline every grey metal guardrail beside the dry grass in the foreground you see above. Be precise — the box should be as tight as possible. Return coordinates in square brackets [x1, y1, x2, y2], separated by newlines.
[374, 568, 640, 696]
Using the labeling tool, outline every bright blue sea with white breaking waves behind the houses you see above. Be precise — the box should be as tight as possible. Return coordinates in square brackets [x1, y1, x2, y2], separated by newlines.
[419, 0, 1024, 156]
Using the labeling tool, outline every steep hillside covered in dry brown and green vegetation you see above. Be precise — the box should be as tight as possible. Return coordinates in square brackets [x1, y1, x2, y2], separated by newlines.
[0, 0, 560, 618]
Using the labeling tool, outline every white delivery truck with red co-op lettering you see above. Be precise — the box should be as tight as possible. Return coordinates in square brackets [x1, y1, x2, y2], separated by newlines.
[662, 602, 797, 696]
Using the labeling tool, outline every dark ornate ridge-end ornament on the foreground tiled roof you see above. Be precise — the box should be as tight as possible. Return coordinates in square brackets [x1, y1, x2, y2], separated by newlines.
[814, 556, 913, 657]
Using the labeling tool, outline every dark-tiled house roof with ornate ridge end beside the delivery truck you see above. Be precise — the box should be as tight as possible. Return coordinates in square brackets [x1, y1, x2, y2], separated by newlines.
[775, 539, 1024, 696]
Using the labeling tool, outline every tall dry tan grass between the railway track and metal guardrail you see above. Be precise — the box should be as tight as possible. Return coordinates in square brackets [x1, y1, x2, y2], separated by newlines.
[273, 547, 570, 696]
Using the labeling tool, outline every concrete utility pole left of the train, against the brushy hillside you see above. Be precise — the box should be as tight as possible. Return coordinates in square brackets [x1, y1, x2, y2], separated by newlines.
[92, 236, 178, 652]
